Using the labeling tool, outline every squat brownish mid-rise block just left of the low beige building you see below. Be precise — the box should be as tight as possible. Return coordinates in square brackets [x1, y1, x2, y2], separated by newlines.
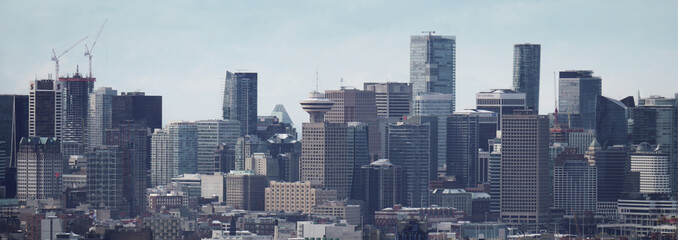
[226, 171, 268, 211]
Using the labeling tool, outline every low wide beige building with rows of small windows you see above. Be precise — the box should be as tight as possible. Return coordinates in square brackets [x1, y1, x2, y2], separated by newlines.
[266, 181, 337, 214]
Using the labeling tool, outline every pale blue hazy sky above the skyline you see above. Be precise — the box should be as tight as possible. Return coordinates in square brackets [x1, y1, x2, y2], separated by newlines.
[0, 0, 678, 127]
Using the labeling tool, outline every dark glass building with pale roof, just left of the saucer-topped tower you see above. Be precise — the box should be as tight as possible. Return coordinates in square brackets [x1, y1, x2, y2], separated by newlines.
[267, 134, 301, 182]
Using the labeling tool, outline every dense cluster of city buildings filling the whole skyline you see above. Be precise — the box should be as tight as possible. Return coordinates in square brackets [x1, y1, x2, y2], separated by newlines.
[0, 34, 678, 239]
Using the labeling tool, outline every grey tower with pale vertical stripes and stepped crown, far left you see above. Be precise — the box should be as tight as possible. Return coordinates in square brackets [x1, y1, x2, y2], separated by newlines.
[17, 137, 63, 202]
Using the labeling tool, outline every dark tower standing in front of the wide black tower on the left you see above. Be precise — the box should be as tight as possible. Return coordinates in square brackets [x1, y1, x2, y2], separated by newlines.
[106, 124, 151, 216]
